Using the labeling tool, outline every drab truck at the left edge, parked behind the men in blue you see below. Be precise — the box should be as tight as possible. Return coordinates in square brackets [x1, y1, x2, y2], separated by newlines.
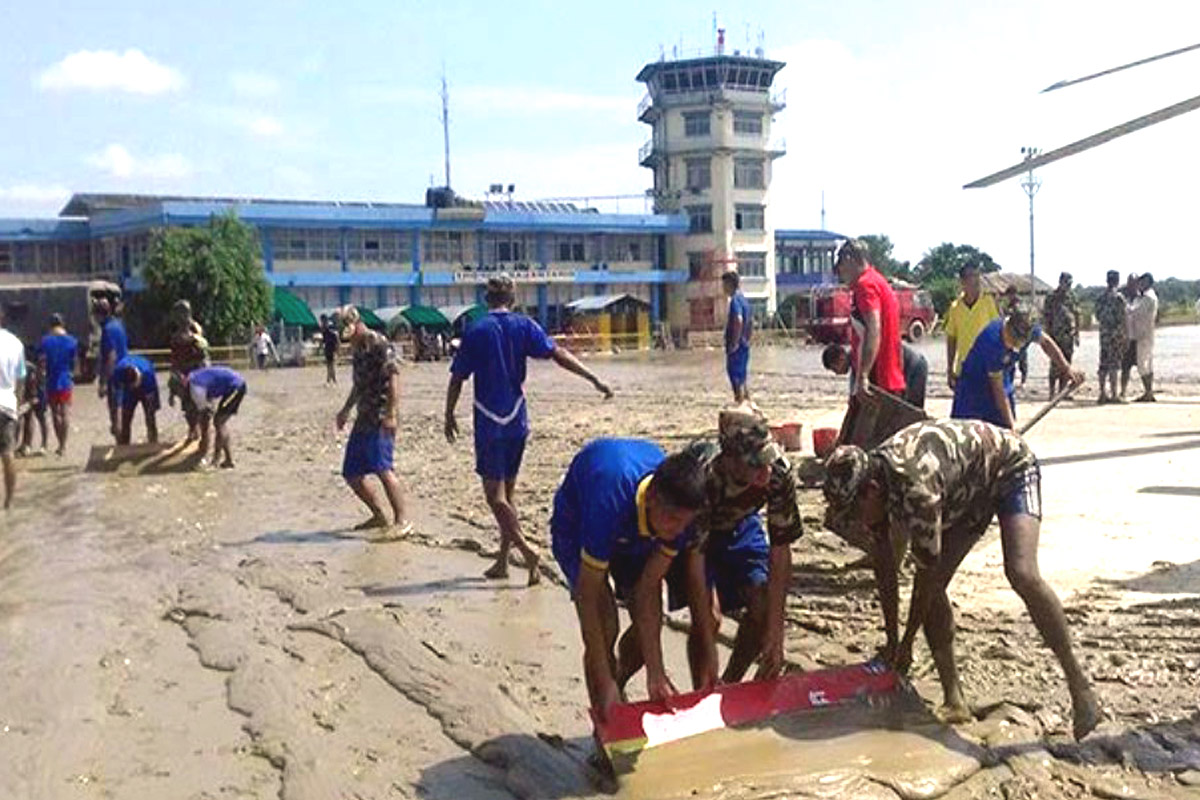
[0, 281, 121, 383]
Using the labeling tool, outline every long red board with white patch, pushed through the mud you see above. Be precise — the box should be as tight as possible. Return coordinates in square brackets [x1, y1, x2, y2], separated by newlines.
[592, 662, 900, 759]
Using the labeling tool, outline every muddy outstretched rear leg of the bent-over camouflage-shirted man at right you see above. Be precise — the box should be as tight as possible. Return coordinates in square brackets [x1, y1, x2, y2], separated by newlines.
[1000, 513, 1100, 739]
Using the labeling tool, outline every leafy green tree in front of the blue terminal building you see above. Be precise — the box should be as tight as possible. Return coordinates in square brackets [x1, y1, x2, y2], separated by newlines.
[136, 212, 271, 343]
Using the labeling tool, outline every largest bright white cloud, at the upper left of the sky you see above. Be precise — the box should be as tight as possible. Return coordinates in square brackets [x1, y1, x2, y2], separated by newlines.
[37, 49, 184, 95]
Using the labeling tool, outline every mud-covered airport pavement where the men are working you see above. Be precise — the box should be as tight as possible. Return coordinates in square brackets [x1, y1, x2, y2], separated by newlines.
[0, 341, 1200, 800]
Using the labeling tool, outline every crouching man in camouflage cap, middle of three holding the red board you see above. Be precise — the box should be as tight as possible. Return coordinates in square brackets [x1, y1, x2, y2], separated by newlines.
[667, 403, 804, 688]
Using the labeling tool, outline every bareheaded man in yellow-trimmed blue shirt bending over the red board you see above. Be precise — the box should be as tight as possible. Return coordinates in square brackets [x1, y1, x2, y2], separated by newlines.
[550, 439, 706, 716]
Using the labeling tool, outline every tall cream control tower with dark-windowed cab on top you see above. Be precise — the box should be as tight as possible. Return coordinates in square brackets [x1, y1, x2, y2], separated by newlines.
[637, 31, 786, 330]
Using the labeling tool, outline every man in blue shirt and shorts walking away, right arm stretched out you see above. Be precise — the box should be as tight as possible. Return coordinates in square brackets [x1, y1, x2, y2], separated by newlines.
[445, 273, 612, 587]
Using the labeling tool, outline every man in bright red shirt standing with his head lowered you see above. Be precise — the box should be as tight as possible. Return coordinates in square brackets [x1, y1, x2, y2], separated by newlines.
[836, 239, 905, 397]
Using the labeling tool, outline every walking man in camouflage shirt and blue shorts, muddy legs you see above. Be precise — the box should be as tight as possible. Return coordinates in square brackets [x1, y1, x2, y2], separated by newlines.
[337, 306, 412, 534]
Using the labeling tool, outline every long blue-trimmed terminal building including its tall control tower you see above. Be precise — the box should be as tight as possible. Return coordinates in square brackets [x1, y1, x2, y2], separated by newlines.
[0, 41, 841, 332]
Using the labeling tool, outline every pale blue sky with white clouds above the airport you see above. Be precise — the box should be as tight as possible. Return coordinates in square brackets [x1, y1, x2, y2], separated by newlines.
[0, 0, 1200, 283]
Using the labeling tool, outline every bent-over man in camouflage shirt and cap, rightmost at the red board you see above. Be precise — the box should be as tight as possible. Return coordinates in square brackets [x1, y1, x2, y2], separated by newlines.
[824, 420, 1099, 739]
